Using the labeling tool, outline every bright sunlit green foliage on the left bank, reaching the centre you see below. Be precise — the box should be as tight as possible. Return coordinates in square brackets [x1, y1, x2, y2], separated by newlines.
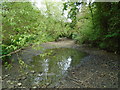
[2, 2, 70, 62]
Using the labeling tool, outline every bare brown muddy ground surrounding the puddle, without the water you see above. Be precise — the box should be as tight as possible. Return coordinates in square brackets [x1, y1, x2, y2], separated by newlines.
[3, 40, 120, 88]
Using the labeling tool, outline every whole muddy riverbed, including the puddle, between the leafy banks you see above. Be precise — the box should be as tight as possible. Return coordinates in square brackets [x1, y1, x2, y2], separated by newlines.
[2, 40, 120, 88]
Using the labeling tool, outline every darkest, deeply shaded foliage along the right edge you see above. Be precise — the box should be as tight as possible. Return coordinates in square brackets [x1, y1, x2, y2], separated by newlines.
[94, 2, 120, 52]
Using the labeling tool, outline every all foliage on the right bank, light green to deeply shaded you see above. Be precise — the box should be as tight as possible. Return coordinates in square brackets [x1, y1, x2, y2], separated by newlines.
[64, 2, 120, 52]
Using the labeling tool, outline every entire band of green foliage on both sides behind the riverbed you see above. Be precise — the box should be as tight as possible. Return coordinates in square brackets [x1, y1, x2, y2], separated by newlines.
[2, 2, 120, 62]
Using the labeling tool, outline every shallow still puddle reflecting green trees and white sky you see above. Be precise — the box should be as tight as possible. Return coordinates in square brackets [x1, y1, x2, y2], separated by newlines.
[31, 48, 85, 86]
